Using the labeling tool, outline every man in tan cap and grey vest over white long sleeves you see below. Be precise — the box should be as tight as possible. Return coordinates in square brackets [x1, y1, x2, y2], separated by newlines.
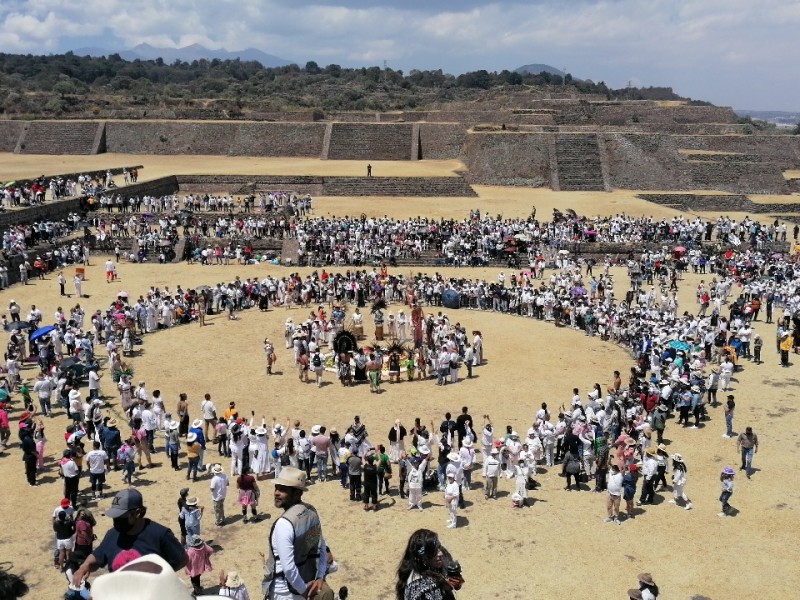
[263, 467, 333, 600]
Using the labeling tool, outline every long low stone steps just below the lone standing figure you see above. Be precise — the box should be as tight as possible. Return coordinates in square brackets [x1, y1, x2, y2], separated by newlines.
[322, 177, 477, 198]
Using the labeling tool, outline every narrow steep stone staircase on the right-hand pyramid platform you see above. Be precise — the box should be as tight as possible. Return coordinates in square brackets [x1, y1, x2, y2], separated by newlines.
[555, 133, 605, 192]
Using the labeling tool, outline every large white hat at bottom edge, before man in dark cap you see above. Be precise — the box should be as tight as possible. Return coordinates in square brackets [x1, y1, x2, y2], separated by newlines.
[92, 554, 192, 600]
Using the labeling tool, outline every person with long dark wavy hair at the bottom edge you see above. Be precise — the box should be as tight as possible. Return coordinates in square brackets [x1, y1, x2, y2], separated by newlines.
[395, 529, 455, 600]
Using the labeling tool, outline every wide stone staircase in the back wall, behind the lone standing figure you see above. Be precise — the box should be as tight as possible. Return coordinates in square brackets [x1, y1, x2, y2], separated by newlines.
[323, 123, 417, 161]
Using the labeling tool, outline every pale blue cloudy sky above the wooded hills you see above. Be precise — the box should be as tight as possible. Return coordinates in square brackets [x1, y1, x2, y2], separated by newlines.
[0, 0, 800, 112]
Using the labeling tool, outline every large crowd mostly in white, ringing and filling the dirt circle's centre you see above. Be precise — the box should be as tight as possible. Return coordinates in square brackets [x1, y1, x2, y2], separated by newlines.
[0, 195, 800, 600]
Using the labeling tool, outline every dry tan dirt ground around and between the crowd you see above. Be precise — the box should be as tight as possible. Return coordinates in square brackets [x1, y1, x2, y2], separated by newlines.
[0, 155, 800, 600]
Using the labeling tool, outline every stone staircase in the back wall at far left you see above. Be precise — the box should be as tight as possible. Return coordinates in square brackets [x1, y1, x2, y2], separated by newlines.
[15, 121, 105, 154]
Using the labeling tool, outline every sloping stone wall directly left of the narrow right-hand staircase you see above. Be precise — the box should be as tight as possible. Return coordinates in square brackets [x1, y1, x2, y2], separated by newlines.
[463, 131, 552, 187]
